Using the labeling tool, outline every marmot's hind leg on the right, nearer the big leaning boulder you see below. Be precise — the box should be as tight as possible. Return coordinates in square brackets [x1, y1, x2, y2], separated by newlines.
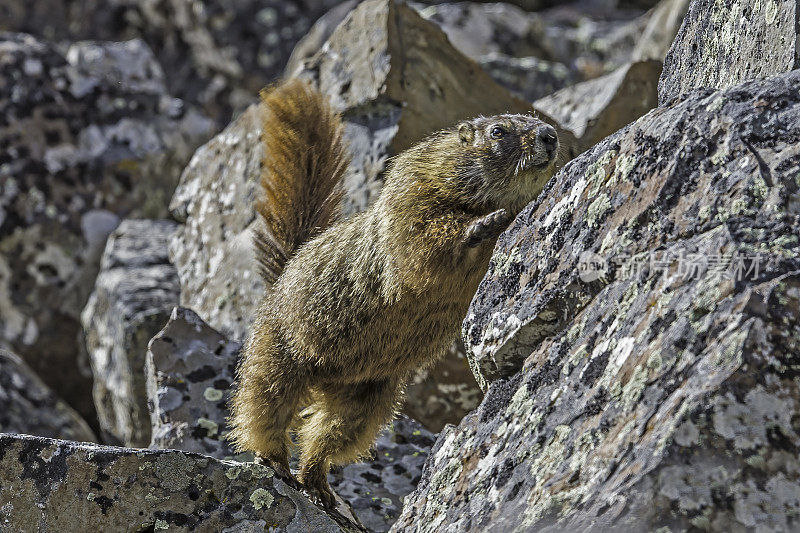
[298, 380, 402, 507]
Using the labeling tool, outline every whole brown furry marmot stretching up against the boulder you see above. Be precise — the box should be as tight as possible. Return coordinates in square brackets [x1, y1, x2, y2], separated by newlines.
[229, 80, 559, 506]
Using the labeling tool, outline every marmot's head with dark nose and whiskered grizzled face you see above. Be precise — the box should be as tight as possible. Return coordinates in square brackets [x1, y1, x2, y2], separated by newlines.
[456, 115, 559, 212]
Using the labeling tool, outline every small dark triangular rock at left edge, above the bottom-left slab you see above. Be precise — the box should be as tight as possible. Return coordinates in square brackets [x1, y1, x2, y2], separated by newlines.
[0, 350, 96, 440]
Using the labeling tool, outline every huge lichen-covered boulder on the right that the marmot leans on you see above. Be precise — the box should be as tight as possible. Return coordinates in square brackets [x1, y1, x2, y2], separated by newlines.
[394, 71, 800, 532]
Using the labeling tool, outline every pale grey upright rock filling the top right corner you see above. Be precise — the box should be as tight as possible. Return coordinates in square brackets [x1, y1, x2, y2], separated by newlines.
[658, 0, 800, 105]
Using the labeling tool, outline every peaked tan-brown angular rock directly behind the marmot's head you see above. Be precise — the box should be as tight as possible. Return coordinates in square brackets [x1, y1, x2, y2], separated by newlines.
[298, 0, 572, 158]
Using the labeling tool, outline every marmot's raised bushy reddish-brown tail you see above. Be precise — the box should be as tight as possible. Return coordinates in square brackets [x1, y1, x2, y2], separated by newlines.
[255, 80, 349, 285]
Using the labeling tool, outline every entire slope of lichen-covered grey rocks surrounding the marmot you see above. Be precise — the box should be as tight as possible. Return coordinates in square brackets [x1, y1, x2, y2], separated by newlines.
[0, 0, 800, 532]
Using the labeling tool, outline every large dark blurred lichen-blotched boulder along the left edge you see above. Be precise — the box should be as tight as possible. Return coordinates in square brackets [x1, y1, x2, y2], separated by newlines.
[0, 33, 212, 420]
